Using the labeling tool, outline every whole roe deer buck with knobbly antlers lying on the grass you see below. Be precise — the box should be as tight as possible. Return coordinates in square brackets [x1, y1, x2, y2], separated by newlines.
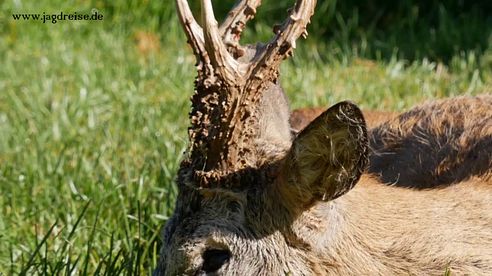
[155, 0, 492, 275]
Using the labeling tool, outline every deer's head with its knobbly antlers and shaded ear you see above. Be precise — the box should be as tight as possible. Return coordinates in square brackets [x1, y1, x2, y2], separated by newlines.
[156, 0, 367, 275]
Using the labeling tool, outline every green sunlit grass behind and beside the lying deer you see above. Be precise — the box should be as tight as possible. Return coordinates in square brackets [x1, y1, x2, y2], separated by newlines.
[0, 0, 492, 275]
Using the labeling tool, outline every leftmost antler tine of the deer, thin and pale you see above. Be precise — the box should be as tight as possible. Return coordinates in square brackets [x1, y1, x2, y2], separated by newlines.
[176, 0, 210, 64]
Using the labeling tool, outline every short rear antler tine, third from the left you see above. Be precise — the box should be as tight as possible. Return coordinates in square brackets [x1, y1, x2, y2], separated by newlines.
[220, 0, 261, 51]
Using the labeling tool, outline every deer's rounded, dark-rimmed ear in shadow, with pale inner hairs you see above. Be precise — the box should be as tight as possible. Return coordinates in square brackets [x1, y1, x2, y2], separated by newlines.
[280, 102, 368, 205]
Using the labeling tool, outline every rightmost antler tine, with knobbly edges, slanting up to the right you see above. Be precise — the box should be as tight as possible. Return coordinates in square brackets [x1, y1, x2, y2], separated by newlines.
[248, 0, 316, 87]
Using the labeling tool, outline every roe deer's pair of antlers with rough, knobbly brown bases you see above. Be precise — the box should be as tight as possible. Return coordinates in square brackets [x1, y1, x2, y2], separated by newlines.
[176, 0, 316, 178]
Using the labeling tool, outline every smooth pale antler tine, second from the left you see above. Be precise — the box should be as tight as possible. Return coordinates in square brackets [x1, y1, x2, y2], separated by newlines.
[201, 0, 241, 84]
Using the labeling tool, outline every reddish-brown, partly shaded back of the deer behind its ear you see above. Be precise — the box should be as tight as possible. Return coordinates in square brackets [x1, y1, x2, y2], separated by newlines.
[369, 96, 492, 188]
